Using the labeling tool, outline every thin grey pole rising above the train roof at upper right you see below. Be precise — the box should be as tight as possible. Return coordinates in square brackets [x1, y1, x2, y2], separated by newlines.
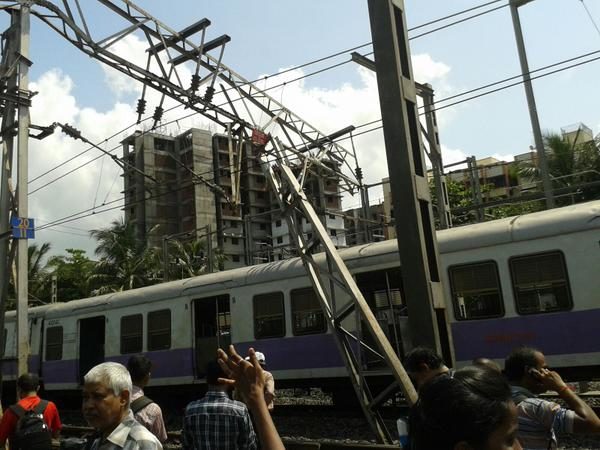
[510, 0, 554, 209]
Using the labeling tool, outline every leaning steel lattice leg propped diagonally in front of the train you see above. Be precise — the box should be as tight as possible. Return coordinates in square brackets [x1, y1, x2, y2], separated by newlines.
[262, 151, 417, 443]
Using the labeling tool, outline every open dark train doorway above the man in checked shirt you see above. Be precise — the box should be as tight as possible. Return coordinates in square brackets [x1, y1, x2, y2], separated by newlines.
[193, 295, 231, 378]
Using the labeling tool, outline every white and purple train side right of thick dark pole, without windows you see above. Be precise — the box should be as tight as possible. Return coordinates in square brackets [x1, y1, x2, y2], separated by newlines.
[443, 230, 600, 367]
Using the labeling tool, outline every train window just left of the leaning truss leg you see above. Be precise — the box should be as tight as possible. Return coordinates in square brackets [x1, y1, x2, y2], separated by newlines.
[291, 288, 327, 336]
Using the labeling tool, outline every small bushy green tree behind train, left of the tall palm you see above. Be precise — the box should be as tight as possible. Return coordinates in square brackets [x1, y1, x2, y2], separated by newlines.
[47, 248, 95, 302]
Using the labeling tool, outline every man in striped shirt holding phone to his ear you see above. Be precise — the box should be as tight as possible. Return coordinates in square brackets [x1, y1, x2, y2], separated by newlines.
[504, 347, 600, 450]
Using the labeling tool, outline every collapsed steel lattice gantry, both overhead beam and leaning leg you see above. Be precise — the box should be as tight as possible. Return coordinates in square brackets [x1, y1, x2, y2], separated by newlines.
[0, 0, 424, 442]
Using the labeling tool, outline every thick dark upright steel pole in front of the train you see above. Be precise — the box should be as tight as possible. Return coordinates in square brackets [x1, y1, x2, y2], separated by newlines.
[368, 0, 454, 364]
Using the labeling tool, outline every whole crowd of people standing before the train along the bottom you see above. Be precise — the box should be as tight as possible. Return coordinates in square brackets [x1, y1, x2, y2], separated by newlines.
[0, 346, 600, 450]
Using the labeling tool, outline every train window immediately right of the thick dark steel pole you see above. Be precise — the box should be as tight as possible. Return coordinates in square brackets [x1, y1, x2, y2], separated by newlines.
[448, 261, 504, 320]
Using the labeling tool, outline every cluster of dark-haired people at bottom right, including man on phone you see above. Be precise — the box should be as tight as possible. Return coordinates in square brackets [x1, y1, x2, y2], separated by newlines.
[404, 347, 600, 450]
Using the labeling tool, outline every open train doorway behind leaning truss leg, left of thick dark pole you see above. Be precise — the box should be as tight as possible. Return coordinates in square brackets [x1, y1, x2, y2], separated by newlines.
[356, 268, 408, 364]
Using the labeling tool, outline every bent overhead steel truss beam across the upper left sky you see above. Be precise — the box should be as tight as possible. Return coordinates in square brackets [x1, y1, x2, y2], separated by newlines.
[17, 0, 359, 194]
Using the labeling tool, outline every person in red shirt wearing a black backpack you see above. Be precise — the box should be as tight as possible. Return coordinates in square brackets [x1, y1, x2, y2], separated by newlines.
[0, 373, 62, 450]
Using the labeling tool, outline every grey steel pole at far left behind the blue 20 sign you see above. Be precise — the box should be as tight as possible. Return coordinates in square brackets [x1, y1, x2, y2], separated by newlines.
[17, 3, 31, 375]
